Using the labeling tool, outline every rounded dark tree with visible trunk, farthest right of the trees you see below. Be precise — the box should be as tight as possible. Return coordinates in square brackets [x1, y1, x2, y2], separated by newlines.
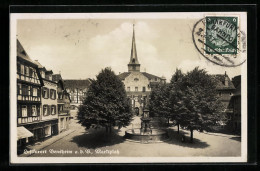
[179, 67, 224, 142]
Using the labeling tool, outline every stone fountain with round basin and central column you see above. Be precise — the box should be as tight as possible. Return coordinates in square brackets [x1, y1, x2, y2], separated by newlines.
[125, 109, 168, 143]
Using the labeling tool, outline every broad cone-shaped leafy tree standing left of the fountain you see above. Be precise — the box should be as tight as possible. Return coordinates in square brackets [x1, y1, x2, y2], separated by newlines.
[79, 68, 132, 132]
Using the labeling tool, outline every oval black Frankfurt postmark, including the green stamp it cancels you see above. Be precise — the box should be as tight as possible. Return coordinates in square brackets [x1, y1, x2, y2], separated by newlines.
[192, 16, 246, 67]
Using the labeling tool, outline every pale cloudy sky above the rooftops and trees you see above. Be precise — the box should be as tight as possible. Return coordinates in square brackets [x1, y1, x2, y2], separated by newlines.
[16, 18, 241, 81]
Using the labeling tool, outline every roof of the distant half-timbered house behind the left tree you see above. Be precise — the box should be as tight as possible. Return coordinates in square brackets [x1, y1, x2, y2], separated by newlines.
[63, 79, 91, 89]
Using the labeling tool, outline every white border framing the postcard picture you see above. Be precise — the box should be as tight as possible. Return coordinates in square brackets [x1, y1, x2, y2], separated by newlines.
[9, 12, 247, 164]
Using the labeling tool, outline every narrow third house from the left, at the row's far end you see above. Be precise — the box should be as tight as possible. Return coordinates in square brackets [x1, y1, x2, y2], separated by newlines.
[52, 74, 70, 132]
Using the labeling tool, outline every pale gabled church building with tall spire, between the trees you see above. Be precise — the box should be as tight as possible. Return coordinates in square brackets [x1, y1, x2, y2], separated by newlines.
[118, 24, 166, 115]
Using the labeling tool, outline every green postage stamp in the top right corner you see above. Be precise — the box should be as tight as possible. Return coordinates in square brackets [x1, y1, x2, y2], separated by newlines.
[205, 16, 238, 54]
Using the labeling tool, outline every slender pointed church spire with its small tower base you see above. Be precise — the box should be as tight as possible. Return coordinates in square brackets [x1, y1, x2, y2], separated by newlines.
[128, 25, 140, 72]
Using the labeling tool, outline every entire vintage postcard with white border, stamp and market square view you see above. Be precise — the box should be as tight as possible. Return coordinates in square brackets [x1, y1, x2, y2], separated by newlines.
[10, 12, 247, 164]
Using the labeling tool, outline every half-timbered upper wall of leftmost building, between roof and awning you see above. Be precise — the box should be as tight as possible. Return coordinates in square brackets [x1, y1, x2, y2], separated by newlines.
[17, 58, 41, 126]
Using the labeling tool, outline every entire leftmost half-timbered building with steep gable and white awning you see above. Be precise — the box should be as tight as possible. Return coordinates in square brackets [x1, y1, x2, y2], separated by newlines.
[17, 40, 45, 147]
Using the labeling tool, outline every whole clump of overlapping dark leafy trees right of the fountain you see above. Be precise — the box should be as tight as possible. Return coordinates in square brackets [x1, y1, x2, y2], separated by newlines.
[150, 67, 224, 141]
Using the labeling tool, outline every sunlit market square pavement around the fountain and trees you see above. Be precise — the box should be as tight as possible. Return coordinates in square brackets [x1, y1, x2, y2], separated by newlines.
[21, 112, 241, 157]
